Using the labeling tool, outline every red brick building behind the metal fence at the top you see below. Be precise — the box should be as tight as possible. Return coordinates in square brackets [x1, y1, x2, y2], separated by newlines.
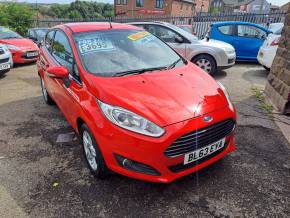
[114, 0, 209, 17]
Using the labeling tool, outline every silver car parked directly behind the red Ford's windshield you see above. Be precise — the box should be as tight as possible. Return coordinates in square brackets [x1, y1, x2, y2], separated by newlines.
[131, 22, 236, 74]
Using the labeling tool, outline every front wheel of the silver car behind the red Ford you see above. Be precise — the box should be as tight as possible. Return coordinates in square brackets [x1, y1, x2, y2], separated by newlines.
[192, 54, 217, 74]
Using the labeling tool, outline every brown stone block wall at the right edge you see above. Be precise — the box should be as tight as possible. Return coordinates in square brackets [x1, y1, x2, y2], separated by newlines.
[265, 3, 290, 114]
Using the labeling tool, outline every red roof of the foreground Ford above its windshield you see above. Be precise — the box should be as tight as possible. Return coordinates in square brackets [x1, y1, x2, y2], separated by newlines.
[55, 22, 140, 33]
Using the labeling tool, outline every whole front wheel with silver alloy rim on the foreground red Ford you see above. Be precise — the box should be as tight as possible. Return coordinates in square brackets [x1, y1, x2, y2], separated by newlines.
[80, 124, 109, 179]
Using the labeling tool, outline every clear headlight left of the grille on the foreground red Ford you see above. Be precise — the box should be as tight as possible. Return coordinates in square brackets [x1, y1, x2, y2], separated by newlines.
[97, 100, 165, 137]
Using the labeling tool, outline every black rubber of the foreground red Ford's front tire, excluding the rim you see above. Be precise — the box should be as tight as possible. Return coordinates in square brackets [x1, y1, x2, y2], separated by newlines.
[80, 124, 109, 179]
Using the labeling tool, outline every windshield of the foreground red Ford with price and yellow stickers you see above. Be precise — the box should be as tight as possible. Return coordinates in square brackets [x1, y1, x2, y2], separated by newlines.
[74, 30, 184, 77]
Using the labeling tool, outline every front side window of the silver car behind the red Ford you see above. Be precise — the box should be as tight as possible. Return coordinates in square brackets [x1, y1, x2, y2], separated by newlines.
[146, 25, 178, 43]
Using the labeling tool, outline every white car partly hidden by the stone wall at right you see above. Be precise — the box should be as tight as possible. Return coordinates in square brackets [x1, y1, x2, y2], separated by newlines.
[257, 23, 284, 71]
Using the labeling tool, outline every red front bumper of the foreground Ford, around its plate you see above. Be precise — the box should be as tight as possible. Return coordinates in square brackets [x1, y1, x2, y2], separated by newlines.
[96, 105, 236, 183]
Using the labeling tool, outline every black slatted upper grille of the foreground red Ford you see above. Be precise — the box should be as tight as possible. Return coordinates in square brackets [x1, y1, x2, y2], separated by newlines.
[164, 119, 236, 157]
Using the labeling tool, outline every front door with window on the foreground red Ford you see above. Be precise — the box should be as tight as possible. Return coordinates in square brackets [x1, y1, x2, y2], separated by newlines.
[50, 30, 82, 125]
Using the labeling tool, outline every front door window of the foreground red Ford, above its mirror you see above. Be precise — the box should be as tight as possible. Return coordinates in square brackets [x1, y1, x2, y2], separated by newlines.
[52, 31, 79, 78]
